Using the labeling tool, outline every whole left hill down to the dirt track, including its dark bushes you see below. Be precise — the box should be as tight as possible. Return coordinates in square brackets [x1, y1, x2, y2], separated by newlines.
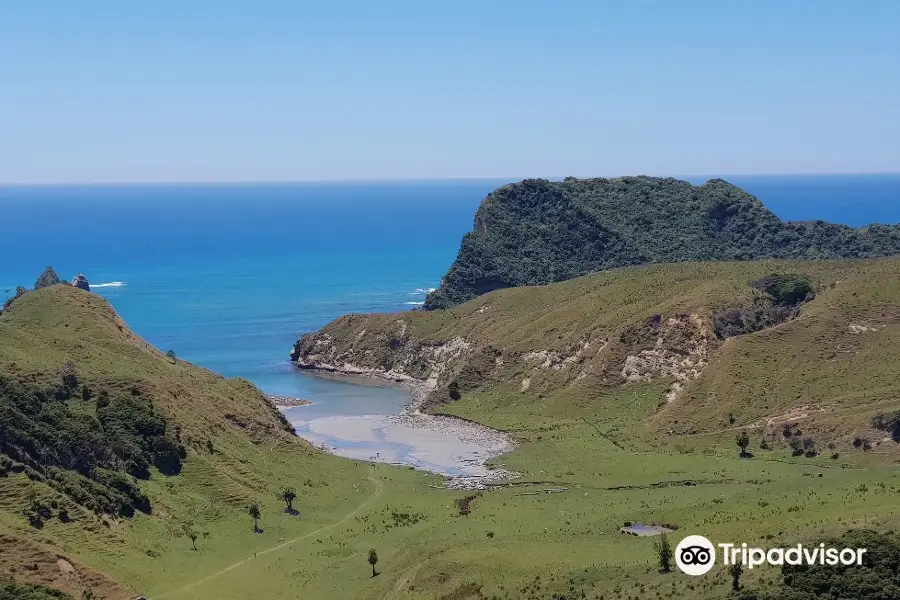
[0, 285, 398, 600]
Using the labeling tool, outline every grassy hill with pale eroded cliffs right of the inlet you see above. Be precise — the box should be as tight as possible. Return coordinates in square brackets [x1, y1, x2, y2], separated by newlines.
[293, 259, 900, 455]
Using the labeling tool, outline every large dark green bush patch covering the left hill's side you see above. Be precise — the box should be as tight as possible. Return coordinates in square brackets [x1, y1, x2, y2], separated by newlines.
[0, 365, 185, 516]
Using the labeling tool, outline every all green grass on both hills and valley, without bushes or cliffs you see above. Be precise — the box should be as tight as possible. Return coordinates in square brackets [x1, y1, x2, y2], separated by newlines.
[0, 268, 900, 600]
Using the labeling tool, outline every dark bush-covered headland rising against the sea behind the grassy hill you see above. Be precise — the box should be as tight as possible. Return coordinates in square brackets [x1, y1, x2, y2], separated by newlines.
[425, 177, 900, 309]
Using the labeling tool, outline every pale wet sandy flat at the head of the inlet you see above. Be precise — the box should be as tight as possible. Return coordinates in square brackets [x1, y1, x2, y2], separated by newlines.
[282, 376, 515, 489]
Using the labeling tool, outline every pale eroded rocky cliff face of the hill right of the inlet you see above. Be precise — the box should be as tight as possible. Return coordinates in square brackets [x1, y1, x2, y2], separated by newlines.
[291, 304, 719, 406]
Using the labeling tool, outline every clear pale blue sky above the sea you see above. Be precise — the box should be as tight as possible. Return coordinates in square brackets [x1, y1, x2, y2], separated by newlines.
[0, 0, 900, 183]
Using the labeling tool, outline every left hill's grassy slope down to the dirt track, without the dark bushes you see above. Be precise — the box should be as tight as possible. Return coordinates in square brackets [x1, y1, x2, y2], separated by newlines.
[0, 286, 428, 597]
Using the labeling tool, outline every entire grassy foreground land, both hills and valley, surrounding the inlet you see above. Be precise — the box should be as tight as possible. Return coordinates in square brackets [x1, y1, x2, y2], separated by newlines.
[0, 276, 900, 600]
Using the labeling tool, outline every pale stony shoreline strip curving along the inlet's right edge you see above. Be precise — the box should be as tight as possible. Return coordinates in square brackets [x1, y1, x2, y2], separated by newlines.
[294, 362, 518, 489]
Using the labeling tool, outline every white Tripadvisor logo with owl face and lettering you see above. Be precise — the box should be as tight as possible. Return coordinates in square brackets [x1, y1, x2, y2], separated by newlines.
[675, 535, 866, 575]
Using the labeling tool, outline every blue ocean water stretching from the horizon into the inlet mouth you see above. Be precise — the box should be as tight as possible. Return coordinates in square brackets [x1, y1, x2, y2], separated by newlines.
[0, 175, 900, 412]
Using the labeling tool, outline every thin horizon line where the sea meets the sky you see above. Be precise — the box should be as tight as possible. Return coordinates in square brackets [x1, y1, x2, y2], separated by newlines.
[0, 170, 900, 188]
